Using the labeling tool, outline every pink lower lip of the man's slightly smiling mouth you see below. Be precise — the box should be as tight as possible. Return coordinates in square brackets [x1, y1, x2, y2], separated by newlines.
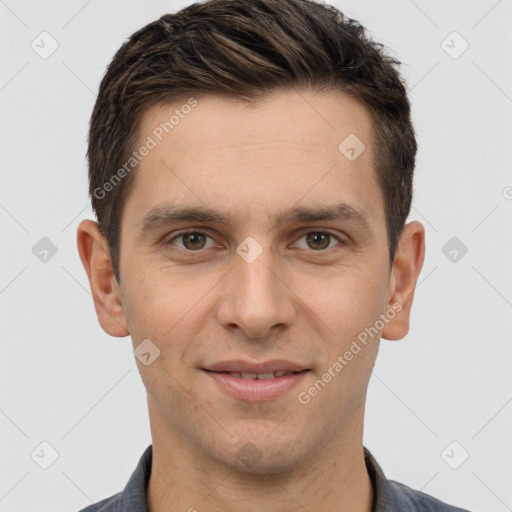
[204, 370, 309, 402]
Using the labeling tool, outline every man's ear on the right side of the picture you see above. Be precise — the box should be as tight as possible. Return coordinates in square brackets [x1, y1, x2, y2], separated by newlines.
[382, 221, 425, 340]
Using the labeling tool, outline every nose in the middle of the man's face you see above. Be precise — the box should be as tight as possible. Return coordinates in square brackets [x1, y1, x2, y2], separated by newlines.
[217, 248, 296, 339]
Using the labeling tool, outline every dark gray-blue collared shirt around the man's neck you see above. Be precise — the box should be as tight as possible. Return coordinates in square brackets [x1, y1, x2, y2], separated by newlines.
[76, 445, 468, 512]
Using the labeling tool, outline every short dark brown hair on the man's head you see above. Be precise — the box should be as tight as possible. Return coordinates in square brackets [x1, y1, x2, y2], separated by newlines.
[87, 0, 417, 282]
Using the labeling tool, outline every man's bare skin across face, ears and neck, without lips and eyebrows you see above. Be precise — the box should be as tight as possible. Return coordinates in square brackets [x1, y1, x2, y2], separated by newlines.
[77, 90, 425, 512]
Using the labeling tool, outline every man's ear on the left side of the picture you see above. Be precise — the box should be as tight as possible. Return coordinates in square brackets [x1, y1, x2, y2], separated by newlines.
[77, 220, 130, 337]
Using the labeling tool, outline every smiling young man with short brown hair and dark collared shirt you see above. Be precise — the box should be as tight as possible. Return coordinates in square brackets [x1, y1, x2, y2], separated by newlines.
[77, 0, 472, 512]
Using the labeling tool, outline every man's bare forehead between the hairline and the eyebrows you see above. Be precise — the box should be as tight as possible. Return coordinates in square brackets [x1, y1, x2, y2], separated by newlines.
[122, 90, 382, 230]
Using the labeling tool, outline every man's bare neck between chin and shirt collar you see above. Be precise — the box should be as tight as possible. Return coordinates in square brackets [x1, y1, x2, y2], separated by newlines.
[147, 404, 374, 512]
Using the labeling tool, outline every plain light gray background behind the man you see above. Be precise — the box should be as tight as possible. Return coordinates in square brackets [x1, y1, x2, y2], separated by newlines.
[0, 0, 512, 512]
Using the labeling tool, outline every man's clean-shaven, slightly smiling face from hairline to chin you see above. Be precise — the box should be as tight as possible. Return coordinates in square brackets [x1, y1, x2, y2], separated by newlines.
[90, 91, 414, 472]
